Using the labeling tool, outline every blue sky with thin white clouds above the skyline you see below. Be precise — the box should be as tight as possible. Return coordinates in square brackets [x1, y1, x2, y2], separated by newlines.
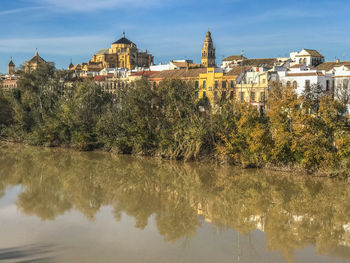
[0, 0, 350, 72]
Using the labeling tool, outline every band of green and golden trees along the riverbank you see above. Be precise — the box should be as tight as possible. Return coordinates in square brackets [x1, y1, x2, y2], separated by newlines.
[0, 65, 350, 176]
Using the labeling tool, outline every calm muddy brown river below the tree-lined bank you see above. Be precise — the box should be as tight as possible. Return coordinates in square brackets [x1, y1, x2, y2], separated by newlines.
[0, 144, 350, 263]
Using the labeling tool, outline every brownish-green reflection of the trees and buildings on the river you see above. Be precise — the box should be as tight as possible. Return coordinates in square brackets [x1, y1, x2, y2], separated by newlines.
[0, 144, 350, 262]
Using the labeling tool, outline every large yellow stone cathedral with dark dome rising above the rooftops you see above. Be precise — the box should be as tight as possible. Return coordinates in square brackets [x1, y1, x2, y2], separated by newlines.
[89, 33, 153, 69]
